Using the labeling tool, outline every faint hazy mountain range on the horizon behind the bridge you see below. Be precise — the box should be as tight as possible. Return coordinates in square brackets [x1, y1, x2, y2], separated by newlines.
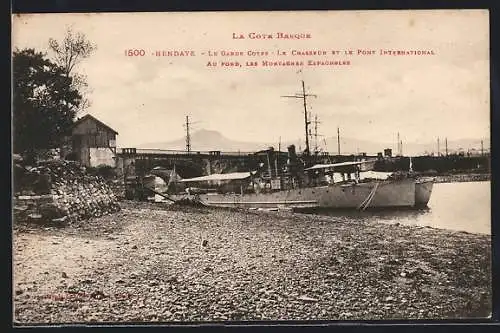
[137, 129, 490, 155]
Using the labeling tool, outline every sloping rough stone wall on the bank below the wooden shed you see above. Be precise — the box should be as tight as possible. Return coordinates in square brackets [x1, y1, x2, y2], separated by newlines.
[14, 161, 120, 223]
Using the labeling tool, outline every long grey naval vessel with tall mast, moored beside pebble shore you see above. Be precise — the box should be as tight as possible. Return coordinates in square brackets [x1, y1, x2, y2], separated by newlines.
[162, 81, 434, 210]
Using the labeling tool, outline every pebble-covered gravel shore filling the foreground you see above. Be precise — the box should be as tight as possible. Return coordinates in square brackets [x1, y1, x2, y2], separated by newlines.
[13, 202, 491, 324]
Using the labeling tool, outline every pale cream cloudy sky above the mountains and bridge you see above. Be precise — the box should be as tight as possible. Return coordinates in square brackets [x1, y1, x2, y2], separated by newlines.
[12, 10, 490, 147]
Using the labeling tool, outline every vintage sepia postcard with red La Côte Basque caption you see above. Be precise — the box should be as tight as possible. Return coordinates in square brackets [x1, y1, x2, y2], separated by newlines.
[12, 10, 492, 325]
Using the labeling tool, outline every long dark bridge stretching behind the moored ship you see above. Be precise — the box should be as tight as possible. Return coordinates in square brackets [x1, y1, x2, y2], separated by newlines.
[116, 148, 489, 178]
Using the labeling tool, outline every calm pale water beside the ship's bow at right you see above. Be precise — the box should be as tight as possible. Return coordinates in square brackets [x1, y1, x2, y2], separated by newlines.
[318, 181, 491, 234]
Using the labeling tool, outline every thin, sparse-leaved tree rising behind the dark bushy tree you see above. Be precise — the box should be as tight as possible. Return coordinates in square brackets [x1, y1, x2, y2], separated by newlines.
[49, 27, 97, 112]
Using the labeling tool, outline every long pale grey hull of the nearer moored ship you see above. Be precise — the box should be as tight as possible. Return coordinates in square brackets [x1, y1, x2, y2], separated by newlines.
[189, 179, 416, 209]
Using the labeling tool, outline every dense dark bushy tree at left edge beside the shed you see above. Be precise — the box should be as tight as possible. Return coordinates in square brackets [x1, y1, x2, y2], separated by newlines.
[12, 49, 82, 153]
